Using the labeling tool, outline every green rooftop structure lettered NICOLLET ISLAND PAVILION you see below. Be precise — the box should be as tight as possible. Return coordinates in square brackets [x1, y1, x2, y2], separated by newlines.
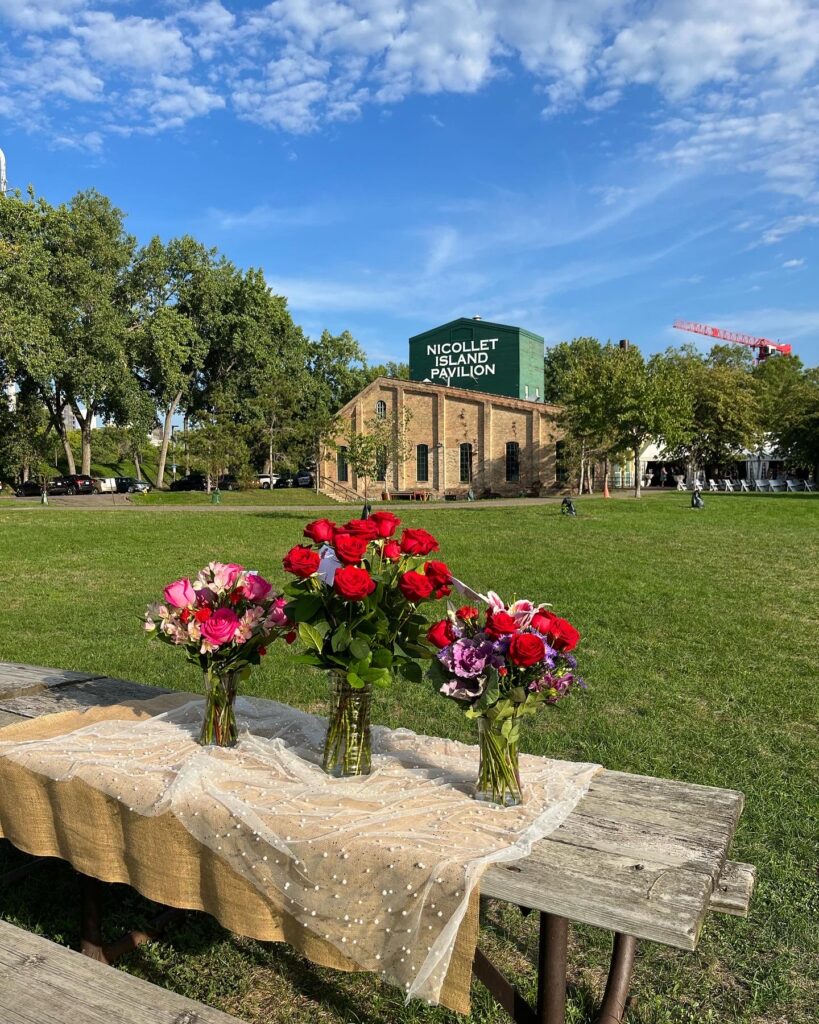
[410, 316, 544, 401]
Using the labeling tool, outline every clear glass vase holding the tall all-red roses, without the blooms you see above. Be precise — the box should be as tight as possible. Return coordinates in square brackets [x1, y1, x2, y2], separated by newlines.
[321, 672, 373, 778]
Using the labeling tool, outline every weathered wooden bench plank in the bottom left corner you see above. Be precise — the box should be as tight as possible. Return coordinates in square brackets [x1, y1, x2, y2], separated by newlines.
[0, 921, 236, 1024]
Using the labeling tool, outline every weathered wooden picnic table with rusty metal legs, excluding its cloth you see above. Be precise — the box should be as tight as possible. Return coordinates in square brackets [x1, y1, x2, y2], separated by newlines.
[0, 663, 756, 1024]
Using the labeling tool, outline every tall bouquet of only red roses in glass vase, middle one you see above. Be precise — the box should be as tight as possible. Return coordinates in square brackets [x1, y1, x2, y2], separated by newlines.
[284, 511, 451, 775]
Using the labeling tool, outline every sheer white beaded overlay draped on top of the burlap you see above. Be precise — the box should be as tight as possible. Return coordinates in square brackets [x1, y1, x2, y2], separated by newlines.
[0, 698, 600, 1002]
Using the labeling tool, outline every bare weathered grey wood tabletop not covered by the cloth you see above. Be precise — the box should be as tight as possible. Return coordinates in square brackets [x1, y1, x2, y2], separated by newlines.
[0, 663, 755, 1021]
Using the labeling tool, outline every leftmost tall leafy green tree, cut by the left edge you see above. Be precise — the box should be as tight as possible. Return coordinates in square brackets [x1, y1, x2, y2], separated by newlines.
[0, 189, 134, 473]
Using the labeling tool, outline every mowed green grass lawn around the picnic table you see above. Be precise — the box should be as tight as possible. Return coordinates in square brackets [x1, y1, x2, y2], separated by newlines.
[0, 494, 819, 1024]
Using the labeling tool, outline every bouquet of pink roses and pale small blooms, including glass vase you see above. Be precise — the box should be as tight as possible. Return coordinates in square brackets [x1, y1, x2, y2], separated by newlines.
[144, 562, 296, 746]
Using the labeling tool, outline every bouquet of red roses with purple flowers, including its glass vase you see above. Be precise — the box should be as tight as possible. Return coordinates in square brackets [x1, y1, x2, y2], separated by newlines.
[427, 591, 583, 806]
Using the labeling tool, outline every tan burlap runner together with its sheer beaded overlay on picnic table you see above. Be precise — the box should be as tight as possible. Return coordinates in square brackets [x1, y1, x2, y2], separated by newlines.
[0, 694, 599, 1013]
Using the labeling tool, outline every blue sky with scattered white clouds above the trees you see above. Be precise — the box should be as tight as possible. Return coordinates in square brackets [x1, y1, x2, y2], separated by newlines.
[0, 0, 819, 365]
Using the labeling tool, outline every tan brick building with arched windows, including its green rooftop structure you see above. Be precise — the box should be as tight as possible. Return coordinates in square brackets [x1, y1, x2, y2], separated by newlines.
[319, 317, 562, 498]
